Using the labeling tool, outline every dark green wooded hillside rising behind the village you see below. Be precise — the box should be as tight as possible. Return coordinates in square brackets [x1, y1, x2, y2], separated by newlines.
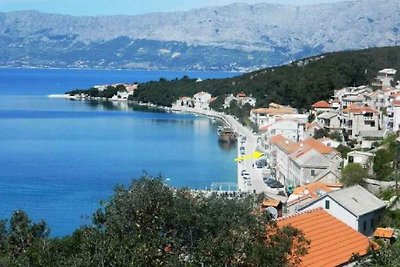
[133, 47, 400, 109]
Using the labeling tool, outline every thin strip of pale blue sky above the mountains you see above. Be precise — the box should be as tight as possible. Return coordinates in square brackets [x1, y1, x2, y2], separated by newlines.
[0, 0, 349, 15]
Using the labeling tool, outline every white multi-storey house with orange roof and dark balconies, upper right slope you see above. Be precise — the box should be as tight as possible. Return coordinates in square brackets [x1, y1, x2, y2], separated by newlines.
[342, 105, 379, 139]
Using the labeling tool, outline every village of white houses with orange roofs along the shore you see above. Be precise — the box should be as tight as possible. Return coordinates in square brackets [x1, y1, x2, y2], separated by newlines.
[172, 69, 400, 266]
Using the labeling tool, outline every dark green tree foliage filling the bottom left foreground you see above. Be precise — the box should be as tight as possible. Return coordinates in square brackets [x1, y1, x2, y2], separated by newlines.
[0, 177, 309, 266]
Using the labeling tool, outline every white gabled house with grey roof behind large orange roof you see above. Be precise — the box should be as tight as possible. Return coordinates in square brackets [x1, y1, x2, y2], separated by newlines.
[299, 185, 386, 236]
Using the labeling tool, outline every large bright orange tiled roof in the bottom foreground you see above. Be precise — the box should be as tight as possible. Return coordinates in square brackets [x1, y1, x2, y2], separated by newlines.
[278, 208, 369, 267]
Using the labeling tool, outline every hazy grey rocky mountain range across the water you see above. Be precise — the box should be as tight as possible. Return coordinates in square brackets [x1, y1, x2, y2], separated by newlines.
[0, 0, 400, 71]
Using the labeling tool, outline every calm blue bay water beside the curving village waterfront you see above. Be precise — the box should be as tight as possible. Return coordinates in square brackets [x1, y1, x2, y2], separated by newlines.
[0, 69, 236, 236]
